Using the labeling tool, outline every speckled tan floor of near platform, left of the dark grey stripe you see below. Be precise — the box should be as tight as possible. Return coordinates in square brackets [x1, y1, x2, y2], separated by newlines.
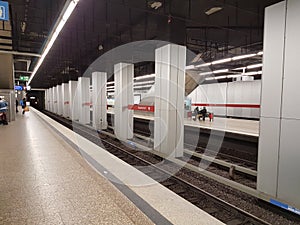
[0, 112, 152, 225]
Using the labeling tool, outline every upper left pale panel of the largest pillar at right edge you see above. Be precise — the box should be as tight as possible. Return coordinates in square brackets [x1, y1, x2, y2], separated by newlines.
[261, 2, 285, 118]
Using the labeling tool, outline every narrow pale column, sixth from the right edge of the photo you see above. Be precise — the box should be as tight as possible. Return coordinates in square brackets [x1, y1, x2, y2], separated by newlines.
[69, 80, 79, 121]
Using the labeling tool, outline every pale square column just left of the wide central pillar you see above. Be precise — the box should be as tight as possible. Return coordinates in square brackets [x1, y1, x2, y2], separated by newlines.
[114, 63, 134, 141]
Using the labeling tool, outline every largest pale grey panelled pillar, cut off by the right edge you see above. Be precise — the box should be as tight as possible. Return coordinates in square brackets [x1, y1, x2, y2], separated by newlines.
[257, 0, 300, 211]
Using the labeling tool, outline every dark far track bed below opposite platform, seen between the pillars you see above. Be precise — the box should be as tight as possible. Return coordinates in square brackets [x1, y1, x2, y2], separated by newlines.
[108, 115, 258, 170]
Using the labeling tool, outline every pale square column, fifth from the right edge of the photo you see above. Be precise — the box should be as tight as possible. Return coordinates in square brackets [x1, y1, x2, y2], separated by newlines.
[77, 77, 91, 124]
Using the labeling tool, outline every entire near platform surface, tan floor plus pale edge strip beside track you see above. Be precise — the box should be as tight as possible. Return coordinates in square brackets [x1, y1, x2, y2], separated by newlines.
[0, 109, 222, 225]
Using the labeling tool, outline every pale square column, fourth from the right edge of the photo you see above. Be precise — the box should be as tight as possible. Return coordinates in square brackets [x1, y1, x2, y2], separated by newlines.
[92, 72, 107, 130]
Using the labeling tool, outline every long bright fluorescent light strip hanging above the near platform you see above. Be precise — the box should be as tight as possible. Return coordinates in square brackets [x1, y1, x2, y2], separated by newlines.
[28, 0, 79, 85]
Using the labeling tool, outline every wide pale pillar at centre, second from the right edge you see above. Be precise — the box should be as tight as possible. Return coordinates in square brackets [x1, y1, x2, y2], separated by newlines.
[154, 44, 186, 157]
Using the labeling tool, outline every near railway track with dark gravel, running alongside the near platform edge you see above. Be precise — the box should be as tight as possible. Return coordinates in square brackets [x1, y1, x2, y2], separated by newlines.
[40, 110, 300, 224]
